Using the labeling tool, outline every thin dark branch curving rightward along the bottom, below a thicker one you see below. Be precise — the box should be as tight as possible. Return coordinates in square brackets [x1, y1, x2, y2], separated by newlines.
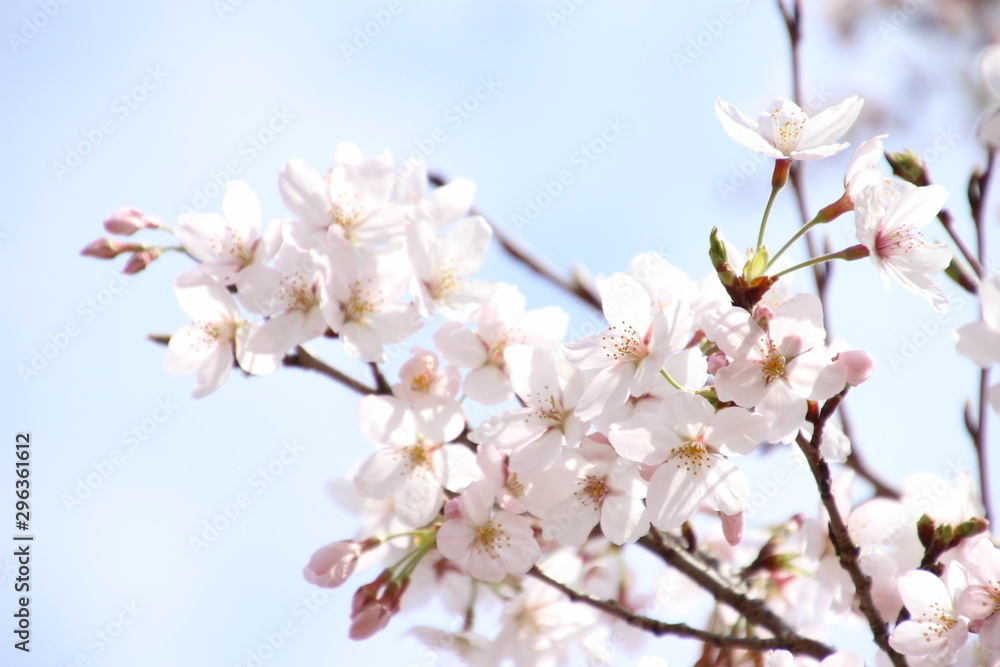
[528, 567, 833, 658]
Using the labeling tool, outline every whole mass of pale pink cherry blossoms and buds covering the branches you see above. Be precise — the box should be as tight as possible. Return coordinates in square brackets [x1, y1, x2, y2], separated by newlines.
[85, 85, 1000, 665]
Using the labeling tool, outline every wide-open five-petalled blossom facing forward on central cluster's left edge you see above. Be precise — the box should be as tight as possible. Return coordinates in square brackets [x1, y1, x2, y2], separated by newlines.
[354, 396, 478, 528]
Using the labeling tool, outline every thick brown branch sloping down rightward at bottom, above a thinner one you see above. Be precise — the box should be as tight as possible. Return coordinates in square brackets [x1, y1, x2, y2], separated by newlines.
[638, 528, 833, 658]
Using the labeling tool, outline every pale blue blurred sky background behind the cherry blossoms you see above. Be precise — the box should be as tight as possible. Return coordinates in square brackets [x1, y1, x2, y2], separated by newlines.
[0, 0, 1000, 667]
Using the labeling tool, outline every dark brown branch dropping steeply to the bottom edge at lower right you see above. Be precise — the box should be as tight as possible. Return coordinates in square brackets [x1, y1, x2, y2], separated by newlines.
[797, 389, 906, 667]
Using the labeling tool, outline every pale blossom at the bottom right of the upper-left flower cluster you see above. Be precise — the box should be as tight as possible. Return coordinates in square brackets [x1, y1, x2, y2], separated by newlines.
[320, 246, 423, 363]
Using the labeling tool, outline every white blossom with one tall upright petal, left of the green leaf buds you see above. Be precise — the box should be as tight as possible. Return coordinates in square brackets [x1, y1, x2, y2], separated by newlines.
[565, 273, 693, 421]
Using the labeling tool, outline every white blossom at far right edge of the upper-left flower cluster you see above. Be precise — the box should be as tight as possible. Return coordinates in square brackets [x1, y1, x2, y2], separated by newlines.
[406, 216, 493, 320]
